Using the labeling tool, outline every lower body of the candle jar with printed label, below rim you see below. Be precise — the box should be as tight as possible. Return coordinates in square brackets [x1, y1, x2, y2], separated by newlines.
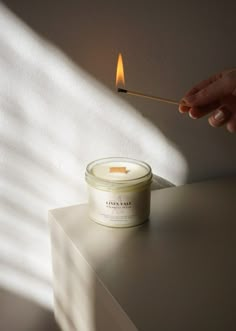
[89, 187, 150, 227]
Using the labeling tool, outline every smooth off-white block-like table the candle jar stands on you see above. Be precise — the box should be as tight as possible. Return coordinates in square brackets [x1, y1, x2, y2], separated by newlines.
[49, 177, 236, 331]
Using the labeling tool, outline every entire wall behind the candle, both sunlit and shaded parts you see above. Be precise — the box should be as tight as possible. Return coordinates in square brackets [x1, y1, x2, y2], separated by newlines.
[0, 0, 236, 306]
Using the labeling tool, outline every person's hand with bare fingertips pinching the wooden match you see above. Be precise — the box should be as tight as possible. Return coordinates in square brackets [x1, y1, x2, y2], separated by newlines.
[179, 69, 236, 132]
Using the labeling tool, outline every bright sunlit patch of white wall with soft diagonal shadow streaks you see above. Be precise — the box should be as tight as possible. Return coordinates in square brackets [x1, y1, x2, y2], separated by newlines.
[0, 5, 187, 307]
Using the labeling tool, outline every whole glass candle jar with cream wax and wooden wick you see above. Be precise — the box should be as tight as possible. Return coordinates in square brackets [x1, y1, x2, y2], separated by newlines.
[85, 157, 152, 227]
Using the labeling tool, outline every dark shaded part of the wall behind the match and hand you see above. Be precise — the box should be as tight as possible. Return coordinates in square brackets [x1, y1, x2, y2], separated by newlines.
[2, 0, 236, 182]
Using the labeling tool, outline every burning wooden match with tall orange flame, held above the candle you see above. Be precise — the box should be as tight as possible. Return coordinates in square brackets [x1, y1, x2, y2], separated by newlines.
[116, 54, 180, 105]
